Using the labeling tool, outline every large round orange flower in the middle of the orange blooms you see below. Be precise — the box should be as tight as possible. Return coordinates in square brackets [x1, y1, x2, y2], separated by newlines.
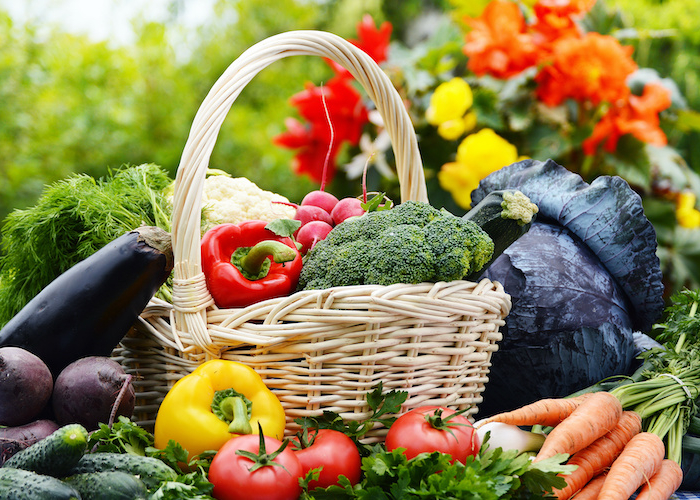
[535, 33, 637, 106]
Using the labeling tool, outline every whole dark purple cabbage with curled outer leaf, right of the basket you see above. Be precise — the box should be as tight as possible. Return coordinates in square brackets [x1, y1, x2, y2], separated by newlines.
[472, 160, 664, 416]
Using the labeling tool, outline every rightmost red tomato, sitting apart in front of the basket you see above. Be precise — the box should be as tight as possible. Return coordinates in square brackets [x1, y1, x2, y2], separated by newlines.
[385, 406, 480, 463]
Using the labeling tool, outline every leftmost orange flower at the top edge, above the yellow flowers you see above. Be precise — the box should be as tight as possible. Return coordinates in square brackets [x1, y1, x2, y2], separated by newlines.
[463, 0, 538, 79]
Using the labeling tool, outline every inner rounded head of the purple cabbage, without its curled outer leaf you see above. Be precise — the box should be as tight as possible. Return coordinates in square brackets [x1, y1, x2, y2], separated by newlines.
[479, 221, 636, 416]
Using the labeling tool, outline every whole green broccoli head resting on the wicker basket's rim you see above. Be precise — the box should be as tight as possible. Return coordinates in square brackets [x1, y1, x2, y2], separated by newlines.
[299, 202, 493, 289]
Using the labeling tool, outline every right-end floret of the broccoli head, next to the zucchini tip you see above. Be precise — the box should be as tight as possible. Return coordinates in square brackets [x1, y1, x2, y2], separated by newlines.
[424, 218, 493, 281]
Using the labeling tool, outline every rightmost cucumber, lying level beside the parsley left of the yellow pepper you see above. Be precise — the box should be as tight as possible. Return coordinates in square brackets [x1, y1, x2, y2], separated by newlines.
[70, 452, 177, 490]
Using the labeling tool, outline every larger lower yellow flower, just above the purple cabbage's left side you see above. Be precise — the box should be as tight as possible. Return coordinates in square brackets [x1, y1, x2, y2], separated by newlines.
[438, 128, 518, 208]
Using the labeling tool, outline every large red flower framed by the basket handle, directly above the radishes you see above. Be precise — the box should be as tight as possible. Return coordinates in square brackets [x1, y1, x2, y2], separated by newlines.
[273, 76, 369, 183]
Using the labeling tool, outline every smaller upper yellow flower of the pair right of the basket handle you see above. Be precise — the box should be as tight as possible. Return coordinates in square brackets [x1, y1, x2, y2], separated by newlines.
[425, 77, 476, 140]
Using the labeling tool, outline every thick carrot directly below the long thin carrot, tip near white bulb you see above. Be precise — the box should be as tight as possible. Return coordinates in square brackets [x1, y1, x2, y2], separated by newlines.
[535, 392, 622, 462]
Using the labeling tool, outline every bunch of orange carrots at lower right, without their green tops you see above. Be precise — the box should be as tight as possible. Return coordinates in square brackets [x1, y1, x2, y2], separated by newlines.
[478, 392, 683, 500]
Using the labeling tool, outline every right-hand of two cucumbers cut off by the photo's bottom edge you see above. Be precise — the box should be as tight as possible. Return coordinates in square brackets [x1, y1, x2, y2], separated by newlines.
[63, 470, 148, 500]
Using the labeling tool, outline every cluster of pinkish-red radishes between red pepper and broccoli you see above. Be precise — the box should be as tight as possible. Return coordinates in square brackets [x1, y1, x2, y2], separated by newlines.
[294, 190, 365, 254]
